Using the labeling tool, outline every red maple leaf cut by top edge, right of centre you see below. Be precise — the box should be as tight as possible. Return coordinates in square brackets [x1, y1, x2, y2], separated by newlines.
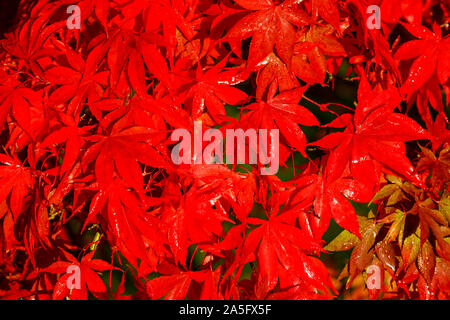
[226, 0, 310, 71]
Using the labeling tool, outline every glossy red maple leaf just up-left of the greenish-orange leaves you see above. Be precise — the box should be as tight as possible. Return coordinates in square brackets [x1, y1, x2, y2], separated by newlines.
[291, 164, 373, 239]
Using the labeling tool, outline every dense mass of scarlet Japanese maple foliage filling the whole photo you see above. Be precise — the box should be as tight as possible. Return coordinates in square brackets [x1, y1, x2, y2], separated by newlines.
[0, 0, 450, 299]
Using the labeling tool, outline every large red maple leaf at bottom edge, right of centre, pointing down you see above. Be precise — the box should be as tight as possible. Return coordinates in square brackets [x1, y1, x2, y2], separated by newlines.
[240, 208, 333, 298]
